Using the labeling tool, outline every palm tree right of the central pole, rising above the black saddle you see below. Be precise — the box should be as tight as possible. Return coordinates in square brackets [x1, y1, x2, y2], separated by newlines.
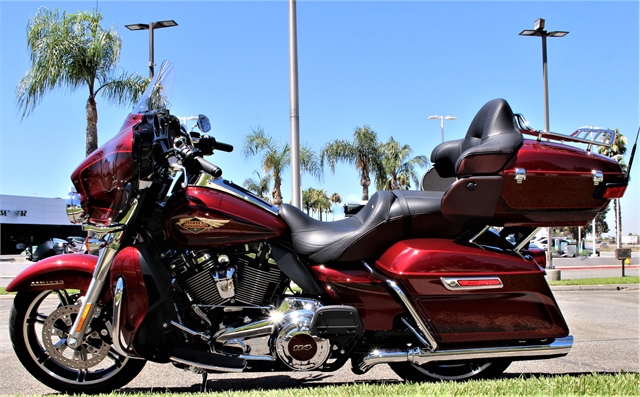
[320, 125, 382, 201]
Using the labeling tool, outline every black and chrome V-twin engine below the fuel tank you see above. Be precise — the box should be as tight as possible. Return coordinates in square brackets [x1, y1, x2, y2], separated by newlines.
[165, 244, 362, 371]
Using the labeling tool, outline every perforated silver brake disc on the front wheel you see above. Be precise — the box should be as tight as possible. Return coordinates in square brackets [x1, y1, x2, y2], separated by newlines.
[42, 305, 111, 370]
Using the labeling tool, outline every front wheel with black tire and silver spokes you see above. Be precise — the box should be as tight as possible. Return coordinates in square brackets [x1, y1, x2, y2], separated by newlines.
[9, 290, 146, 393]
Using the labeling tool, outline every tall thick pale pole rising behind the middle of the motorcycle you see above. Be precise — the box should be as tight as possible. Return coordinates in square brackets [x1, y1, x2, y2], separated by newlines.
[289, 0, 302, 208]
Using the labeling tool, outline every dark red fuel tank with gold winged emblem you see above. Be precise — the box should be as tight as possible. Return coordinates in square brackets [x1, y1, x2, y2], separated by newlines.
[163, 174, 288, 248]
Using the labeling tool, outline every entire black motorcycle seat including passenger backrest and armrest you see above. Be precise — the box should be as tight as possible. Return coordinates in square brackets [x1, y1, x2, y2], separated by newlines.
[280, 99, 522, 263]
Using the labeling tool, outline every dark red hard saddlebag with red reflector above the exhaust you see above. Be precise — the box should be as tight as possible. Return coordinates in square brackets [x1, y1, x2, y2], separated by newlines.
[376, 239, 569, 345]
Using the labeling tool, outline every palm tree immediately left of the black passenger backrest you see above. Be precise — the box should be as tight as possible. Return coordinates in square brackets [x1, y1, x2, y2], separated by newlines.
[376, 137, 429, 190]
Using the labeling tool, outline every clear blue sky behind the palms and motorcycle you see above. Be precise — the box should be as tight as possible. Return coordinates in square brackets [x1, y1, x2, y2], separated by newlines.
[0, 0, 640, 235]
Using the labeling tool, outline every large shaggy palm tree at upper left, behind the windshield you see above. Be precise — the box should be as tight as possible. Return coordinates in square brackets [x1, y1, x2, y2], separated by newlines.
[17, 7, 149, 155]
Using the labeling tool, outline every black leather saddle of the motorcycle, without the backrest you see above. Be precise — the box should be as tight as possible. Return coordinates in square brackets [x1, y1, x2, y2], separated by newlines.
[280, 190, 443, 263]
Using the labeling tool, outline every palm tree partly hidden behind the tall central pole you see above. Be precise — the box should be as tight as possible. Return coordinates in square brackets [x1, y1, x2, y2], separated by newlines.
[242, 127, 322, 207]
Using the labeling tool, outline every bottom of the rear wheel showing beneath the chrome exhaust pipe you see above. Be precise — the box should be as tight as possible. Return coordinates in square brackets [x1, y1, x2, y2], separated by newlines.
[389, 361, 511, 382]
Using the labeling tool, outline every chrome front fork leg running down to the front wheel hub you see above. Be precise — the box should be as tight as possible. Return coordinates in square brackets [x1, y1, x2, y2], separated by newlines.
[67, 199, 138, 350]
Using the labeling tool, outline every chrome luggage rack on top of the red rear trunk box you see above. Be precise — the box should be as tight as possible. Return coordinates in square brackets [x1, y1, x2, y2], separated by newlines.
[514, 114, 616, 151]
